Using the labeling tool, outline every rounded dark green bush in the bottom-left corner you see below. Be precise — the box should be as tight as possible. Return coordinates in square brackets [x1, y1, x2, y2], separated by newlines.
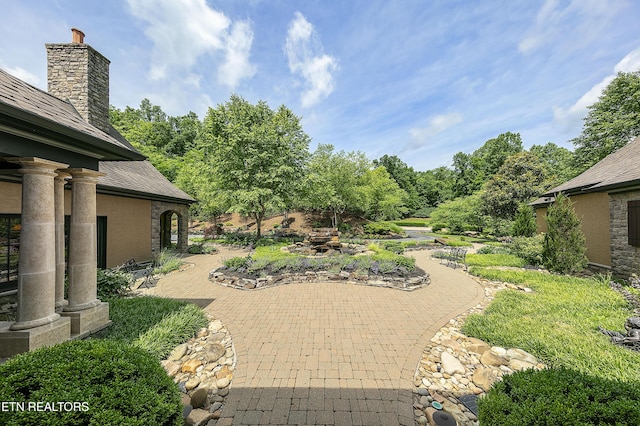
[0, 339, 183, 426]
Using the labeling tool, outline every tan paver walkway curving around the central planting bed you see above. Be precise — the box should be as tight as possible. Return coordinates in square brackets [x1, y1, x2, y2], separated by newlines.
[150, 249, 484, 426]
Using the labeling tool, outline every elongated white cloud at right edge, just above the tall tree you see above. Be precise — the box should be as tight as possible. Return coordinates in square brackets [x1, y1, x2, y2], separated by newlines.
[553, 48, 640, 129]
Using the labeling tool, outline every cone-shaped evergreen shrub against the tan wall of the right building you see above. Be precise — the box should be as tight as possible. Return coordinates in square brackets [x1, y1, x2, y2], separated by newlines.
[542, 193, 587, 274]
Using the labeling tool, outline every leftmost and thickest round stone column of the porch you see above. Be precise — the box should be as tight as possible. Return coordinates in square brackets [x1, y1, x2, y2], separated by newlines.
[6, 158, 67, 331]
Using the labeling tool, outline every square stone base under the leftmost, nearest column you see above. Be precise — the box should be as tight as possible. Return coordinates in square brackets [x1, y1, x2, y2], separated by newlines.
[0, 317, 71, 358]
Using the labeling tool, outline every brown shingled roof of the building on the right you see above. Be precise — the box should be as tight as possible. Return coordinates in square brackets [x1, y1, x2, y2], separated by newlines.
[532, 137, 640, 205]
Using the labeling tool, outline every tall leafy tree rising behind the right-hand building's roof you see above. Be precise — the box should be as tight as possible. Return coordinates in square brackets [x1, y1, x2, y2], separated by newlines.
[572, 71, 640, 172]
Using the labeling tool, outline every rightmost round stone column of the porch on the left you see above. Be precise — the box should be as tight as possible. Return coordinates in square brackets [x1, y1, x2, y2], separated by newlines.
[64, 169, 103, 312]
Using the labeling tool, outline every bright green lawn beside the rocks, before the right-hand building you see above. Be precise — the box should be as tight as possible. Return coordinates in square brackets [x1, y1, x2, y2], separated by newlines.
[463, 268, 640, 381]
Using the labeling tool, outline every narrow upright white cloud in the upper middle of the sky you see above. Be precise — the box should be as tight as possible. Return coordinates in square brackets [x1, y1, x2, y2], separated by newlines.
[285, 12, 338, 107]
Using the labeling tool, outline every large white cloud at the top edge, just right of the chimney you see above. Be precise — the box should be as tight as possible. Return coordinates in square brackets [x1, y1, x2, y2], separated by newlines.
[128, 0, 255, 88]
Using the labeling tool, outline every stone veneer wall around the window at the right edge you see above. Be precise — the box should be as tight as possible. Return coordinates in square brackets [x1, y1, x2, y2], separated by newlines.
[609, 191, 640, 277]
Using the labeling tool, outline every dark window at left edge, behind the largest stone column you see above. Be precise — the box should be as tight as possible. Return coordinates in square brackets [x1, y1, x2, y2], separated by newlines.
[0, 214, 20, 293]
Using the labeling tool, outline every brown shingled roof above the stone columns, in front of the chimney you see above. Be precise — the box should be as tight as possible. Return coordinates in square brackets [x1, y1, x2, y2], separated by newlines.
[0, 69, 145, 160]
